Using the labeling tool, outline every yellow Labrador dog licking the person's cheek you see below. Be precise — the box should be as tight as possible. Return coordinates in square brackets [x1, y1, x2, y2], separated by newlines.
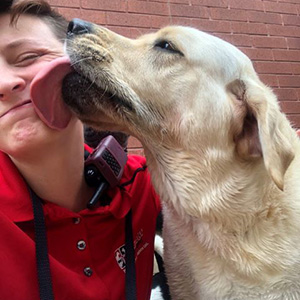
[63, 19, 300, 300]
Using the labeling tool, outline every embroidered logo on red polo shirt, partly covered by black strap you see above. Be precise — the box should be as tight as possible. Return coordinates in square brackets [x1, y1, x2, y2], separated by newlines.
[115, 229, 149, 272]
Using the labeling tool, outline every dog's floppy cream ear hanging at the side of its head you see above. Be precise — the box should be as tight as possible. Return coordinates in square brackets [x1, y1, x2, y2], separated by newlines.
[227, 79, 295, 190]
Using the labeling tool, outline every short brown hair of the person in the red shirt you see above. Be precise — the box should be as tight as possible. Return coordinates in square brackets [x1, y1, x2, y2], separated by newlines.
[0, 0, 68, 40]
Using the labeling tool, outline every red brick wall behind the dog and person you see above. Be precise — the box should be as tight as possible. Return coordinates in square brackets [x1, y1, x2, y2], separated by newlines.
[49, 0, 300, 154]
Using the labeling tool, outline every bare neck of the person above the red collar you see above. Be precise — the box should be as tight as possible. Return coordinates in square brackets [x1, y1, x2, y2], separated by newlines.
[11, 125, 93, 212]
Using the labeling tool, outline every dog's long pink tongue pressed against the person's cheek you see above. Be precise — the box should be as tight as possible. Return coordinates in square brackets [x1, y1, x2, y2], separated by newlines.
[30, 57, 72, 130]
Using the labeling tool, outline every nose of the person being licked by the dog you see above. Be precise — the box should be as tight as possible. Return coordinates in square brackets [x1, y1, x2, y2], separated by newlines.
[0, 68, 26, 101]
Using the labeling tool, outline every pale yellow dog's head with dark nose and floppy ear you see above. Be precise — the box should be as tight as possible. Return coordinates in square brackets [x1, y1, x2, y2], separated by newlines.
[63, 19, 294, 188]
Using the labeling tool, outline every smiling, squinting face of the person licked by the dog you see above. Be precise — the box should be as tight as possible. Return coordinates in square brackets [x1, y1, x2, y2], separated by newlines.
[0, 14, 63, 155]
